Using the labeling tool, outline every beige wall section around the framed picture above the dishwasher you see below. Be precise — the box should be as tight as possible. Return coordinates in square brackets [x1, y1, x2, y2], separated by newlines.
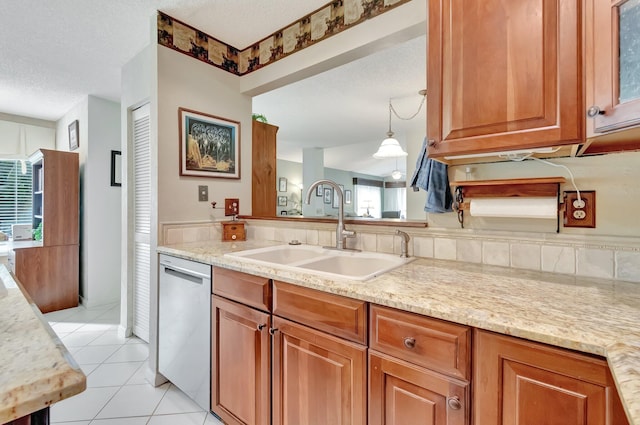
[157, 46, 251, 222]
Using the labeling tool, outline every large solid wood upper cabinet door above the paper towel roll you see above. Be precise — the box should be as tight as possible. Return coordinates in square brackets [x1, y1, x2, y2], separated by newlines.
[427, 0, 584, 157]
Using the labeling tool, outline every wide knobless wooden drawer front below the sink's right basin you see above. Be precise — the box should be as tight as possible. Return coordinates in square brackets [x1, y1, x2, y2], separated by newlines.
[273, 281, 367, 344]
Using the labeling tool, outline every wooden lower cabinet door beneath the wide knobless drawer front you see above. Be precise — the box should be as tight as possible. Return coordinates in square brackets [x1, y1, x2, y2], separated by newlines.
[273, 316, 367, 425]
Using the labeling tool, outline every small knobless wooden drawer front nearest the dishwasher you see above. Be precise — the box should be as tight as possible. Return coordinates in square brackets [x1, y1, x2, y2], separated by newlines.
[213, 267, 271, 311]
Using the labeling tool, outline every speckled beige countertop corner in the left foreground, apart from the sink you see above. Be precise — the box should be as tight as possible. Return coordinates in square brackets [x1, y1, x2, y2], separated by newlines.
[0, 265, 86, 423]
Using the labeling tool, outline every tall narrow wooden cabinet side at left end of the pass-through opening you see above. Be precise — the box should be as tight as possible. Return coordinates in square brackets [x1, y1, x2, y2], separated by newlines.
[251, 120, 278, 217]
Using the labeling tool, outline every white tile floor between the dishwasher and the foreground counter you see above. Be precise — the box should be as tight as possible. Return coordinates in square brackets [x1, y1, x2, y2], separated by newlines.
[44, 305, 222, 425]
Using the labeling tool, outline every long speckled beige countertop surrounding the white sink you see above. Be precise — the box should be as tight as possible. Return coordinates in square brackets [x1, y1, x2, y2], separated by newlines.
[158, 241, 640, 425]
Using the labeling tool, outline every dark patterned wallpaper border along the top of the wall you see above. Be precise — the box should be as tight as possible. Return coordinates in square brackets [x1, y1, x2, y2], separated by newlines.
[158, 0, 411, 75]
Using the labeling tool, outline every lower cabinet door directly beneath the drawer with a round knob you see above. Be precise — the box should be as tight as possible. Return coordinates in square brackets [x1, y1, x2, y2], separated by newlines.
[369, 351, 469, 425]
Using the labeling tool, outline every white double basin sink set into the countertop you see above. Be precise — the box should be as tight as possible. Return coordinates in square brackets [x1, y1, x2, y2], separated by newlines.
[225, 245, 412, 281]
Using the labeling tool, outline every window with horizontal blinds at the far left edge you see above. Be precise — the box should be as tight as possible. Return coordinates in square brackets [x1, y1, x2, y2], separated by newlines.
[0, 159, 32, 236]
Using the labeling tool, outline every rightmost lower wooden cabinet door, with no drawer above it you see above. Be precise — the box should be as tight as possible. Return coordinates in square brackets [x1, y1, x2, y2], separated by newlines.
[473, 330, 628, 425]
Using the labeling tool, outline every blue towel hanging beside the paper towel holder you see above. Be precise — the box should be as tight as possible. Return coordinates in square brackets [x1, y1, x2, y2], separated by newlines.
[411, 138, 453, 213]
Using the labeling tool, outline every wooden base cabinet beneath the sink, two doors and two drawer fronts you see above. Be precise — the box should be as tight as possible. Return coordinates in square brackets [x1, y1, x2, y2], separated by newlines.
[211, 267, 367, 425]
